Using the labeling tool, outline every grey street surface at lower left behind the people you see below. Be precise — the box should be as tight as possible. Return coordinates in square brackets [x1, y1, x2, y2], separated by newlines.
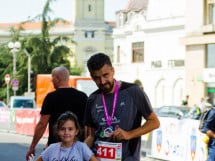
[0, 131, 163, 161]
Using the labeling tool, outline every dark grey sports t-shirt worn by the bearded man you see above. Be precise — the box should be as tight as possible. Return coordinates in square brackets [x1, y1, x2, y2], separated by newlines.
[84, 82, 153, 161]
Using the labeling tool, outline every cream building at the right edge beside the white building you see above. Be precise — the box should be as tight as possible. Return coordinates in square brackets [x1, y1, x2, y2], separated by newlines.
[181, 0, 215, 105]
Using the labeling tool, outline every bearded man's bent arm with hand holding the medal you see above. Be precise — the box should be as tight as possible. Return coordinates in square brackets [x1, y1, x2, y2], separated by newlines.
[112, 112, 160, 140]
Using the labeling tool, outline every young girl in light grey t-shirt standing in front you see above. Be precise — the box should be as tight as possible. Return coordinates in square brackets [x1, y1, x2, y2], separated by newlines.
[36, 111, 98, 161]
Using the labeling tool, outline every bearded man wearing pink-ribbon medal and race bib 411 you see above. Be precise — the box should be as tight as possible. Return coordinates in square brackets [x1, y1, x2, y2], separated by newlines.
[84, 53, 160, 161]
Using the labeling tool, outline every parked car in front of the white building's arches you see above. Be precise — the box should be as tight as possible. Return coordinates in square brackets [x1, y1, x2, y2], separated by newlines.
[154, 105, 189, 119]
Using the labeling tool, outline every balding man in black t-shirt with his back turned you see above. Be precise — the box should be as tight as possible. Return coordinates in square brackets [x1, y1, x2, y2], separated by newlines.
[26, 66, 88, 160]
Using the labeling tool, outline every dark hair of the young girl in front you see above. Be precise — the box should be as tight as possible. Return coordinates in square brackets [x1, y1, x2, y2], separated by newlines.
[56, 111, 81, 139]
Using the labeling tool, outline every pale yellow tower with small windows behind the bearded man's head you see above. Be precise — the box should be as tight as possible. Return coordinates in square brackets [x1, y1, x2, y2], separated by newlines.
[73, 0, 115, 74]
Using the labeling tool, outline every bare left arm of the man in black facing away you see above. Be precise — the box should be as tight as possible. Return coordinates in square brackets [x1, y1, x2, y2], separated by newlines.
[26, 115, 50, 161]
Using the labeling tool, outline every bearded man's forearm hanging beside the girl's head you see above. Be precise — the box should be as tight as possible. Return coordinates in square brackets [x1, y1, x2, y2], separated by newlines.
[84, 126, 95, 148]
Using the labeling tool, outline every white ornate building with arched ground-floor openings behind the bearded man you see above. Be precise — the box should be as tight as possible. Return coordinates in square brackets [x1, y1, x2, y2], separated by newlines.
[113, 0, 188, 107]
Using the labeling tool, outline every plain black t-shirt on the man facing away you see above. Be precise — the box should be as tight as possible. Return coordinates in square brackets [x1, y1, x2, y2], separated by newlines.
[40, 88, 88, 145]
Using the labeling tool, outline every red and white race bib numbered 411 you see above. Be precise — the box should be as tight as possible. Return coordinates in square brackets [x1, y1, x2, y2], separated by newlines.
[96, 141, 122, 161]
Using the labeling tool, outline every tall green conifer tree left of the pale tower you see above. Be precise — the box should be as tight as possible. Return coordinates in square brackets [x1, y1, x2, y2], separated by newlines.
[22, 0, 74, 75]
